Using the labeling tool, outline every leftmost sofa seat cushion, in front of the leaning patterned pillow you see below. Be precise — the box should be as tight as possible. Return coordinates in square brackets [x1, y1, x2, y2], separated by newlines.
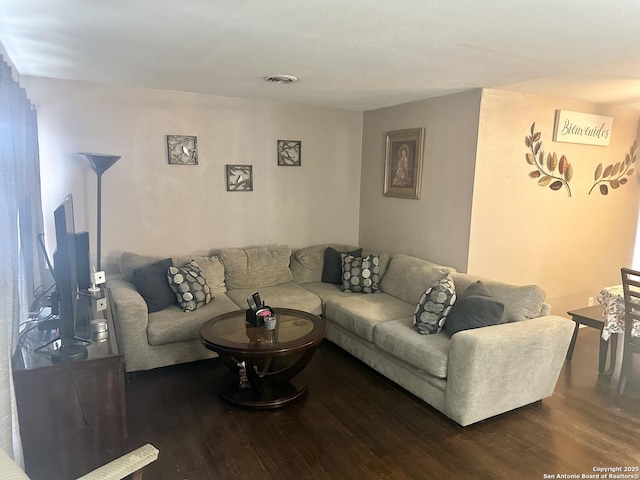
[147, 295, 239, 348]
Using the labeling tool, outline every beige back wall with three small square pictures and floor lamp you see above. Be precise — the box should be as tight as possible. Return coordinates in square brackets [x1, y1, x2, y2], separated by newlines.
[22, 76, 362, 270]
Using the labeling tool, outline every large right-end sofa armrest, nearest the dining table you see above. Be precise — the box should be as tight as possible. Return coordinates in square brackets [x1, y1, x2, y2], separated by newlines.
[445, 315, 574, 426]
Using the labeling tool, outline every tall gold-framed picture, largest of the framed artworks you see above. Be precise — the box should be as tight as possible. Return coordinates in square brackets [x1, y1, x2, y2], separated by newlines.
[383, 128, 424, 200]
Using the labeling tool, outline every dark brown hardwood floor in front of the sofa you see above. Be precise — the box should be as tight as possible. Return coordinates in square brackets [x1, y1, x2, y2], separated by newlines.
[126, 328, 640, 480]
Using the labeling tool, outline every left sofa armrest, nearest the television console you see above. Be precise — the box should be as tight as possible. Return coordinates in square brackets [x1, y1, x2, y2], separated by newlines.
[107, 275, 149, 371]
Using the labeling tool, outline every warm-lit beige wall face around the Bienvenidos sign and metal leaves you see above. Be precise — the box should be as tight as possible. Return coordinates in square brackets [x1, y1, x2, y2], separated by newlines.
[469, 90, 640, 315]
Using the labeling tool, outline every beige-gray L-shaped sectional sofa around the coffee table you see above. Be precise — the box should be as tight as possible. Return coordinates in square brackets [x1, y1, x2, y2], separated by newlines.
[107, 245, 574, 426]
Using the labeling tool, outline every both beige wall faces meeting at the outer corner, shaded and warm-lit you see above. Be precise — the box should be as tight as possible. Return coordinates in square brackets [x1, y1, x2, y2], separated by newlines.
[360, 90, 640, 315]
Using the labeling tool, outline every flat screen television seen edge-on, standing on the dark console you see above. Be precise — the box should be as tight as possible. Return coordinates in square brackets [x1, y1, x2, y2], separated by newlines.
[52, 194, 89, 361]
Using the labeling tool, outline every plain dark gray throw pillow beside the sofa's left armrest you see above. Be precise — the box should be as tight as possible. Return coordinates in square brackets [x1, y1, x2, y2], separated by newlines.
[133, 258, 176, 313]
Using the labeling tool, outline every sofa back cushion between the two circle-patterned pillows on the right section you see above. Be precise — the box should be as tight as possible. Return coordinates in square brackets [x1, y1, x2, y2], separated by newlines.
[380, 253, 455, 308]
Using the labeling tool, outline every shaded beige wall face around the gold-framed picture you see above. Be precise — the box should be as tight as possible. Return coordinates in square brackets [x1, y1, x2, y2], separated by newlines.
[360, 90, 481, 271]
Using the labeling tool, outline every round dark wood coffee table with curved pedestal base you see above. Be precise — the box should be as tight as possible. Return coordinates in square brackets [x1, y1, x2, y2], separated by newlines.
[200, 308, 324, 409]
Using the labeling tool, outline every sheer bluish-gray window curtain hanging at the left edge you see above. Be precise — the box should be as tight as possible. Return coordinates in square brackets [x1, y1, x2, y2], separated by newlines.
[0, 55, 45, 466]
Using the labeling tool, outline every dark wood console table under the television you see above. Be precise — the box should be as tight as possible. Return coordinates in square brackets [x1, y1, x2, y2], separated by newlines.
[13, 289, 127, 480]
